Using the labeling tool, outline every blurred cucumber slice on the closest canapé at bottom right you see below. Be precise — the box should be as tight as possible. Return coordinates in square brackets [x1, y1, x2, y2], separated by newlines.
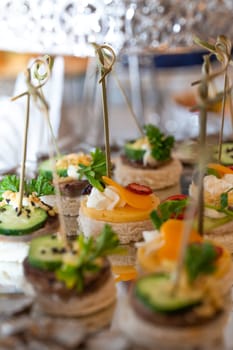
[135, 273, 203, 313]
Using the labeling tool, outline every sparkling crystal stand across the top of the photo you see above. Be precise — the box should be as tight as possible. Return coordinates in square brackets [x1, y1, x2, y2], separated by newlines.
[0, 0, 233, 56]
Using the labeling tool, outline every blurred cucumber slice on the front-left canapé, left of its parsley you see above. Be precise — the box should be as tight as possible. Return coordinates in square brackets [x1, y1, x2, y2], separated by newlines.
[28, 234, 65, 271]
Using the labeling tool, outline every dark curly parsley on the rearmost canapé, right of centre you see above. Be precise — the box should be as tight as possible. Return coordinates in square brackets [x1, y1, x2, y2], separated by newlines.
[144, 124, 175, 161]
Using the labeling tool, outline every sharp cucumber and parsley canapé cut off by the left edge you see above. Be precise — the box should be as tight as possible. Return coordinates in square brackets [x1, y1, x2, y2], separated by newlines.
[0, 175, 59, 261]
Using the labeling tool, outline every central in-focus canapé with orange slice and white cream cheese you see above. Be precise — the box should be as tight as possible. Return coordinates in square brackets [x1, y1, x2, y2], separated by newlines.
[78, 176, 159, 244]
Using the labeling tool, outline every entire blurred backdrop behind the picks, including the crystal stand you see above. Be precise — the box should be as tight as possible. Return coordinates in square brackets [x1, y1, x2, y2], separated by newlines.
[0, 0, 233, 168]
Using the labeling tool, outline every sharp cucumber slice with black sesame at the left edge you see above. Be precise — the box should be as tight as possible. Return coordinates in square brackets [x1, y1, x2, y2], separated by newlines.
[0, 205, 48, 236]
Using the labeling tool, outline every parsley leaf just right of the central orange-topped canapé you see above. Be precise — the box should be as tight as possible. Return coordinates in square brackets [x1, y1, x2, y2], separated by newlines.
[150, 198, 188, 229]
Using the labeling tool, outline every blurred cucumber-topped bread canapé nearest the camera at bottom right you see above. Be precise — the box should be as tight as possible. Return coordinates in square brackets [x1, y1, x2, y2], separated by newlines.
[118, 247, 230, 350]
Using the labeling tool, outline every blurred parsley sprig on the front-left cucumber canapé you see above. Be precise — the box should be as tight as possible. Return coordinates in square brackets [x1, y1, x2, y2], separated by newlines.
[55, 225, 119, 292]
